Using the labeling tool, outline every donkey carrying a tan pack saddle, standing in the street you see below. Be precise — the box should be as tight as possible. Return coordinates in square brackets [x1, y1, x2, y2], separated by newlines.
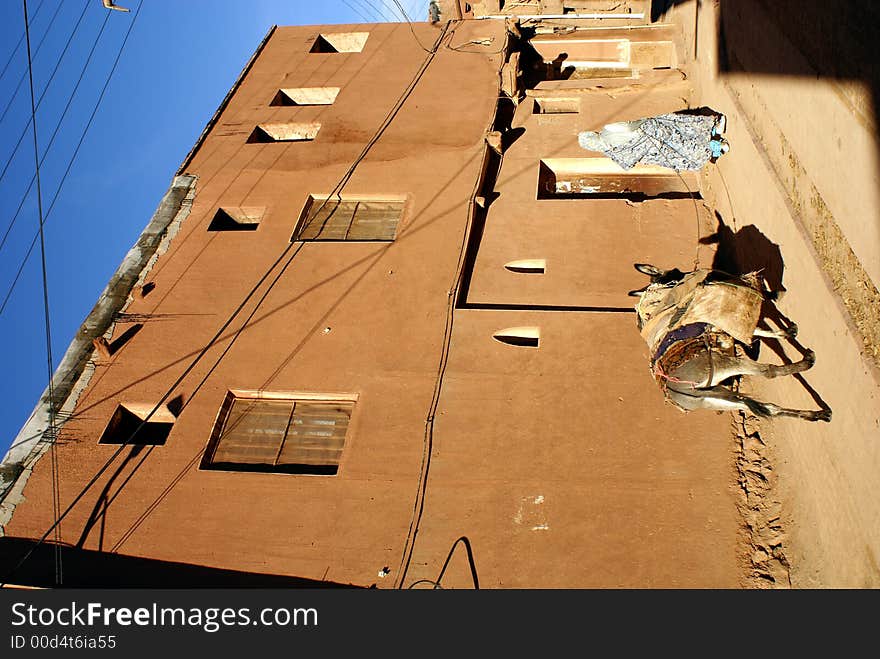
[629, 263, 831, 421]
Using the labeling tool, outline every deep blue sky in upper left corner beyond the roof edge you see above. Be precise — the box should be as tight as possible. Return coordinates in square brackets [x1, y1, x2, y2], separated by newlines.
[0, 0, 428, 456]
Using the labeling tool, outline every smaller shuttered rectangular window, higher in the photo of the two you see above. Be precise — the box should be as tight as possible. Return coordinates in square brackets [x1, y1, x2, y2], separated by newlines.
[291, 195, 404, 241]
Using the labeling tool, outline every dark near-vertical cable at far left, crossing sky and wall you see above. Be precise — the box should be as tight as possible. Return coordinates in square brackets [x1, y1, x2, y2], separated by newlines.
[22, 0, 63, 585]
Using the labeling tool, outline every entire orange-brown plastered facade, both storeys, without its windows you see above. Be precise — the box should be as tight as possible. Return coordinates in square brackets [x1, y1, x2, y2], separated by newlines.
[0, 21, 751, 588]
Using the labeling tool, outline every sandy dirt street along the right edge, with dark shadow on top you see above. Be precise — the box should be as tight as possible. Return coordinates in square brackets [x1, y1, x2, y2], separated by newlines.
[661, 0, 880, 588]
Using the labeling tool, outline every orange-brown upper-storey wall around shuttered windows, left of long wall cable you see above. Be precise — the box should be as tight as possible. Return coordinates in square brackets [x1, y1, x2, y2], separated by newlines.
[5, 22, 505, 585]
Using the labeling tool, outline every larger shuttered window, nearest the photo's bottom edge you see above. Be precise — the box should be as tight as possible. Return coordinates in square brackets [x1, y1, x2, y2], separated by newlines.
[201, 393, 354, 476]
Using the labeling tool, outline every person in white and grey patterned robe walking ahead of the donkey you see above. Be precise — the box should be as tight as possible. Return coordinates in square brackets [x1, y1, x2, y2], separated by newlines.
[578, 112, 727, 171]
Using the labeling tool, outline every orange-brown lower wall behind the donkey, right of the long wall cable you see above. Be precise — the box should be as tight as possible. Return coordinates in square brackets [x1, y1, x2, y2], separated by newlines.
[410, 20, 752, 588]
